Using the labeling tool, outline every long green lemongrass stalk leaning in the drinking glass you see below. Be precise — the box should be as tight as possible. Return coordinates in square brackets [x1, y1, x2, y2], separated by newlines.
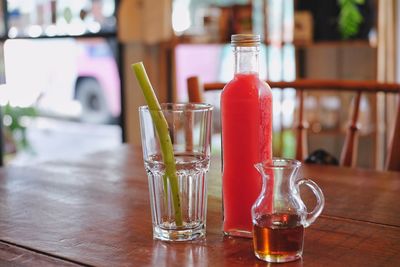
[132, 62, 183, 226]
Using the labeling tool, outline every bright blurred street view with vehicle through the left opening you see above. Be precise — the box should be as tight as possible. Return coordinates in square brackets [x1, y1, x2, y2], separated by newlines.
[0, 0, 122, 164]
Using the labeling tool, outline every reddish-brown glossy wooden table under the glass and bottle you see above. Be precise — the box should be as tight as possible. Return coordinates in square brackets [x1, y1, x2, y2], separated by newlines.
[0, 146, 400, 266]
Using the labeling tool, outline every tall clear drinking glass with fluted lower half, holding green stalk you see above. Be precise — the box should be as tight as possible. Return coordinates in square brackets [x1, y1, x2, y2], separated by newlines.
[139, 103, 213, 241]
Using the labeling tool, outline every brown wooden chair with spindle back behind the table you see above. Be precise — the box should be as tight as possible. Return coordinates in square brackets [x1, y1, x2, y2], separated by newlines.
[187, 76, 400, 171]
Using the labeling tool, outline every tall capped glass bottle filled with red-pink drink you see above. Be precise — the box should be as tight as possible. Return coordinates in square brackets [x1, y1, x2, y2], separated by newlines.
[221, 34, 272, 237]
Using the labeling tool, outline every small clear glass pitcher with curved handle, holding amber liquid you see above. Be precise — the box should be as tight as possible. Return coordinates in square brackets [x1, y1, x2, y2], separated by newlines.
[251, 158, 325, 262]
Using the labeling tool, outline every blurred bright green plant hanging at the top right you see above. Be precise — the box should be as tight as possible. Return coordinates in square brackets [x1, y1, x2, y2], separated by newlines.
[338, 0, 365, 39]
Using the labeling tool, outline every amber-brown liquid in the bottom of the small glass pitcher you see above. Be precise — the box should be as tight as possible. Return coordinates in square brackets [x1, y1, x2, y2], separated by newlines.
[253, 214, 304, 262]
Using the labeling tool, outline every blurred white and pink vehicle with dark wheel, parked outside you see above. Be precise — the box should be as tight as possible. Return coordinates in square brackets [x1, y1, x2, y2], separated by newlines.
[2, 38, 121, 123]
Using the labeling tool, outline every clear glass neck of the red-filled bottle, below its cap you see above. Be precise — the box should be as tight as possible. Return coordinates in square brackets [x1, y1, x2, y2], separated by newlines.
[233, 46, 259, 75]
